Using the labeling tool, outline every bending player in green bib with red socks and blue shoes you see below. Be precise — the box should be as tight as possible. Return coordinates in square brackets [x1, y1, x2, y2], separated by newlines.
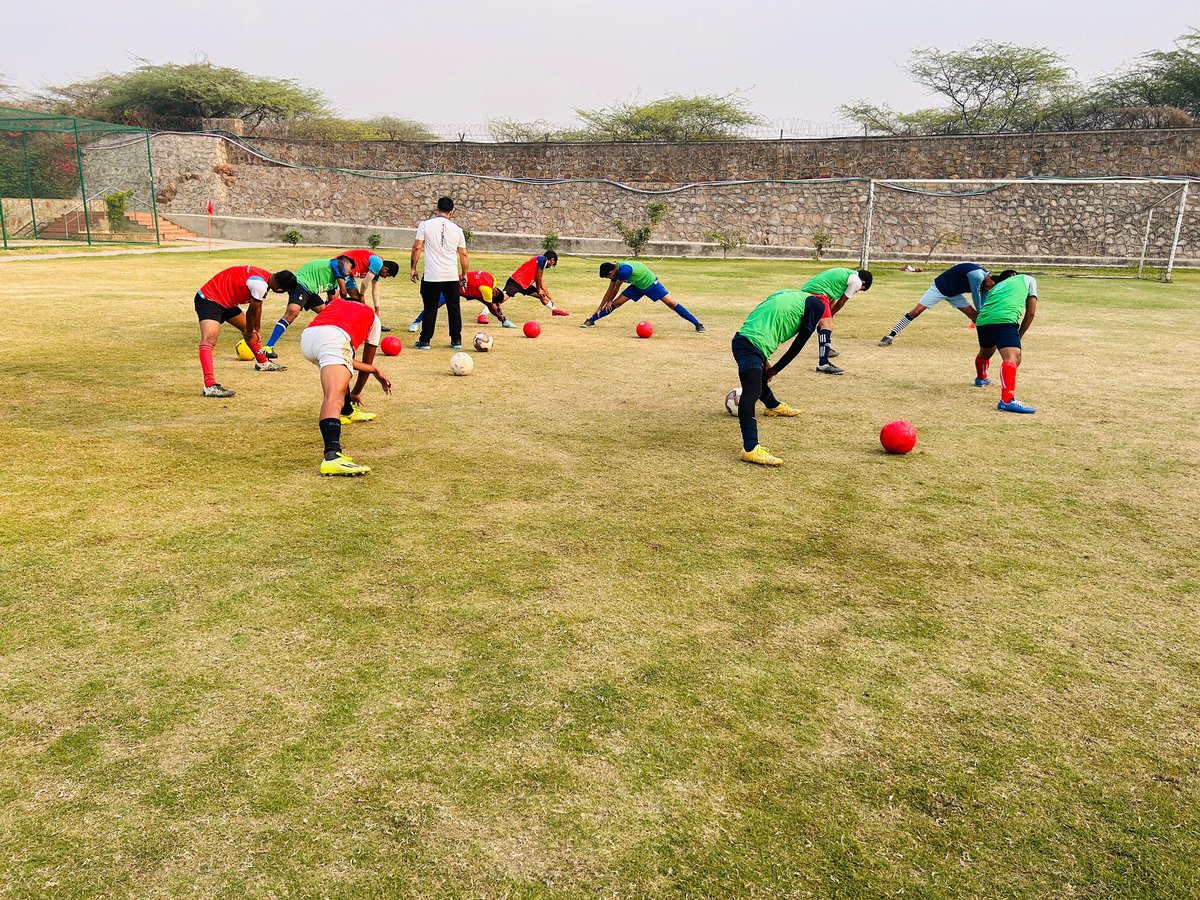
[976, 269, 1038, 413]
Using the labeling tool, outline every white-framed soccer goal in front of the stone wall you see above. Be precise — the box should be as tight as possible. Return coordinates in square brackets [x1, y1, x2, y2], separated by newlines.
[863, 178, 1200, 281]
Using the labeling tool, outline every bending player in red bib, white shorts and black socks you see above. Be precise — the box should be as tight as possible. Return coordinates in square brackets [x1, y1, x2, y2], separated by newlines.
[300, 300, 391, 475]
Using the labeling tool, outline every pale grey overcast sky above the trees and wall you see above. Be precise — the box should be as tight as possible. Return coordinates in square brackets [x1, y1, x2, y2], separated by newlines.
[0, 0, 1200, 133]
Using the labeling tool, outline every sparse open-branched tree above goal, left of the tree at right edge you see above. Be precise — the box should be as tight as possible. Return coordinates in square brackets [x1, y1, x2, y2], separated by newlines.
[841, 41, 1079, 134]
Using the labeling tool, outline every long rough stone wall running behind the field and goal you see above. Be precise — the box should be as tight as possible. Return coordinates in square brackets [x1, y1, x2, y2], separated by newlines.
[140, 130, 1200, 262]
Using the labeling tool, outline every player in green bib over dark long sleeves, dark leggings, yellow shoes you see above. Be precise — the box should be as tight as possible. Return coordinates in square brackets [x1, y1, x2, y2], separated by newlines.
[733, 290, 833, 466]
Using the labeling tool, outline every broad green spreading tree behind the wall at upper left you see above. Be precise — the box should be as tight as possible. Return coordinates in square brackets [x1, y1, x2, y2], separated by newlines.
[43, 61, 329, 130]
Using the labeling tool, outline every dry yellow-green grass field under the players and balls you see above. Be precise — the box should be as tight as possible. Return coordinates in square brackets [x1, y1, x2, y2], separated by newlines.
[0, 248, 1200, 898]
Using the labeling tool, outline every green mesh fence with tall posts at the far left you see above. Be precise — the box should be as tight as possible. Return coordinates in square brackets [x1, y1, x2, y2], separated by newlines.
[0, 107, 158, 250]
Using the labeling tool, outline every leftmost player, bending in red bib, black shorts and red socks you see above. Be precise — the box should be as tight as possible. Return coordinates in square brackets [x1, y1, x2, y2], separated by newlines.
[196, 265, 296, 397]
